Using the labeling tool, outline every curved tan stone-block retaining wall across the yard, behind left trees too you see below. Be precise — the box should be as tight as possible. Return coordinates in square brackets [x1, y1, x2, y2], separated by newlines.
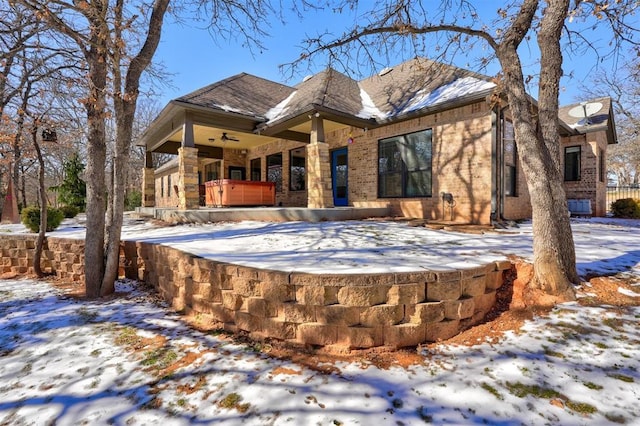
[0, 235, 511, 349]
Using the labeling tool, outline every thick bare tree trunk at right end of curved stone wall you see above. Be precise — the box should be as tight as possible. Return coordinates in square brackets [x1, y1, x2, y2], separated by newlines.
[497, 3, 579, 305]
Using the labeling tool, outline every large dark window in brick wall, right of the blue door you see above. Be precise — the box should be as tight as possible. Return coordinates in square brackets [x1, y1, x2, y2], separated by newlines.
[378, 129, 432, 198]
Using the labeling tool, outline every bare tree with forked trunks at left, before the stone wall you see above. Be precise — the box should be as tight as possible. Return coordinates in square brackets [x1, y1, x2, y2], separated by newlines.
[16, 0, 271, 298]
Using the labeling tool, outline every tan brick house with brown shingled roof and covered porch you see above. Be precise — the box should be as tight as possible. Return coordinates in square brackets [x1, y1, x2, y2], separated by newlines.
[140, 59, 616, 224]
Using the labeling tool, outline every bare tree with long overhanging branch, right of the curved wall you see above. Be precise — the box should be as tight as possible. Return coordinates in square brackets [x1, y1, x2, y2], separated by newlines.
[292, 0, 638, 304]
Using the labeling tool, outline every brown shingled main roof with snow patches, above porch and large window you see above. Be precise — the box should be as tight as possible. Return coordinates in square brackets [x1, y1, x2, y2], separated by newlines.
[175, 58, 495, 127]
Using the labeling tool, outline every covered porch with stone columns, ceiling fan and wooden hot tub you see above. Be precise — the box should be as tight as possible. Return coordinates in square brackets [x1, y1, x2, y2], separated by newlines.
[139, 74, 375, 216]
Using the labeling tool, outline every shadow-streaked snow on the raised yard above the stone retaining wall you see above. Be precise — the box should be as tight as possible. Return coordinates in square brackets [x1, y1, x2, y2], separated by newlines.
[31, 218, 640, 277]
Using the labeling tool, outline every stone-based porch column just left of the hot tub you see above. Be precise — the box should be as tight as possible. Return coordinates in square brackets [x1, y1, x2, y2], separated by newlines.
[179, 113, 200, 210]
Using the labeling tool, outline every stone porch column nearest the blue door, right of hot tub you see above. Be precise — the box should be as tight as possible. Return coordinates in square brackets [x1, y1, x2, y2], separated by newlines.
[307, 113, 333, 209]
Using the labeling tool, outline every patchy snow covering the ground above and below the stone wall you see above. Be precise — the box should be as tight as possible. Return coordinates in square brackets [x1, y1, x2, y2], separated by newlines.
[0, 219, 640, 425]
